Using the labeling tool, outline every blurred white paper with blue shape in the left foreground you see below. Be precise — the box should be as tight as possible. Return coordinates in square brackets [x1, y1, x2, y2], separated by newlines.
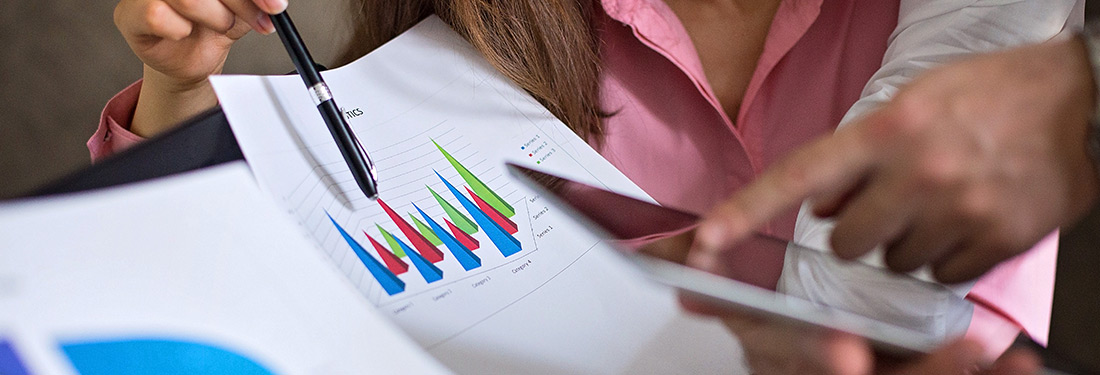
[0, 163, 449, 375]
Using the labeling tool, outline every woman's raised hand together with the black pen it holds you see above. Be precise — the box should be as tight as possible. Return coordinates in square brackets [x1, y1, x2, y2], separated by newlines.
[116, 0, 377, 199]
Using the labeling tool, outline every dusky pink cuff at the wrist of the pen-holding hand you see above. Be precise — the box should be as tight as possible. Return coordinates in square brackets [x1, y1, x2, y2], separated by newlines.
[88, 80, 145, 162]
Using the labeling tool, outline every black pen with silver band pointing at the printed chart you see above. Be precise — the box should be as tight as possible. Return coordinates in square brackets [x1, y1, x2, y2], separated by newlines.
[272, 11, 378, 199]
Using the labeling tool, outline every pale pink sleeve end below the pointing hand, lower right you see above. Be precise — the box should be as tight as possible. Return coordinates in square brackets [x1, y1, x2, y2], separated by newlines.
[966, 231, 1058, 356]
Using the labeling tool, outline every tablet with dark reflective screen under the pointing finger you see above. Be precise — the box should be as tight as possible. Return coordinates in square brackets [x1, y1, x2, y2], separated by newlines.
[507, 164, 968, 357]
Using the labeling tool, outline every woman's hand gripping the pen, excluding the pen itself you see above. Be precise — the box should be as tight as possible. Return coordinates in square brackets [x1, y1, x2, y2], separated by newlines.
[114, 0, 287, 136]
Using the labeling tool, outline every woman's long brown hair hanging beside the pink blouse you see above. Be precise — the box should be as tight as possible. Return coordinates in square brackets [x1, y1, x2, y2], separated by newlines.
[341, 0, 603, 142]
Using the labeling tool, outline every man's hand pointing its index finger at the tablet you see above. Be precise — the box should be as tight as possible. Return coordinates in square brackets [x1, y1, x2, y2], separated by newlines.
[689, 40, 1098, 283]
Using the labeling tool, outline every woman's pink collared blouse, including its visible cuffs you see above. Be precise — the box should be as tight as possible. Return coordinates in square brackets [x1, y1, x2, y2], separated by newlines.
[88, 0, 1073, 354]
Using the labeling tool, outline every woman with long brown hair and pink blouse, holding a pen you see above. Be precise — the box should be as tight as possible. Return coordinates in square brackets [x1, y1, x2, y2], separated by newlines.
[99, 0, 1079, 369]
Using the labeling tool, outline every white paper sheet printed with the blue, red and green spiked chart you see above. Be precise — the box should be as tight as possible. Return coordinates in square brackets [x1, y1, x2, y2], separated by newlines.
[211, 18, 740, 373]
